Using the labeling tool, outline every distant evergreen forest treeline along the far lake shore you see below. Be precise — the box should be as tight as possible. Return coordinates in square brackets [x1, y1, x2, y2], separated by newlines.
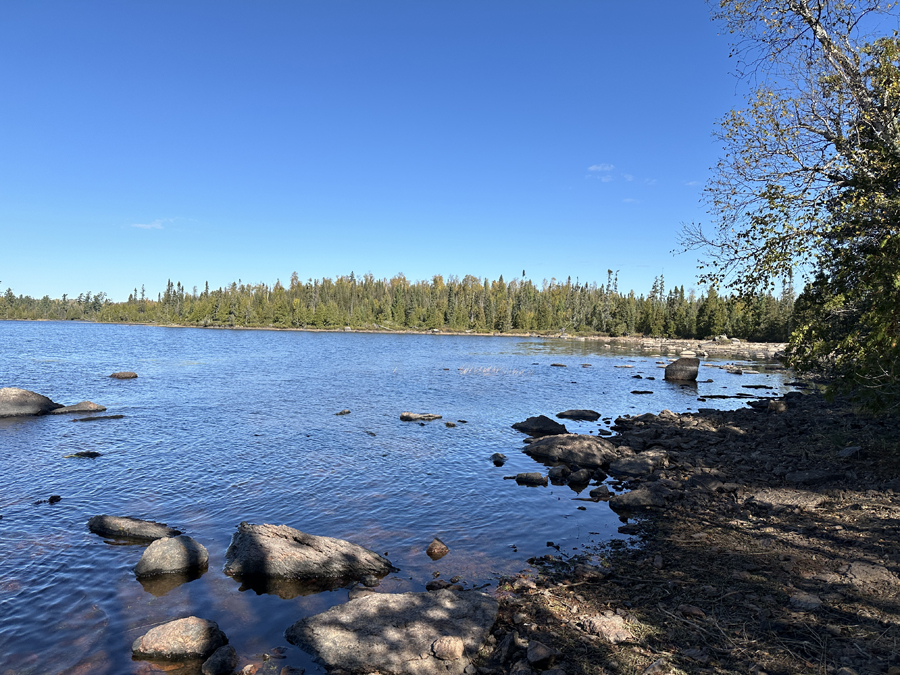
[0, 270, 794, 342]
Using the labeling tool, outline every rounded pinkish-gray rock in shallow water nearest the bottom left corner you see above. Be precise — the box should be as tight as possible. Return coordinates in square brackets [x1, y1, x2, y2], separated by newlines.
[131, 616, 228, 660]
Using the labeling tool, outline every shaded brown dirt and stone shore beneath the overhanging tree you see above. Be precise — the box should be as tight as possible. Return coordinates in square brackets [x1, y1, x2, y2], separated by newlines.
[476, 392, 900, 675]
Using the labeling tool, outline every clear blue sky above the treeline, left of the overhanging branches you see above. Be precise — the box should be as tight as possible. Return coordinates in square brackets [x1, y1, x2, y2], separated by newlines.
[0, 0, 742, 300]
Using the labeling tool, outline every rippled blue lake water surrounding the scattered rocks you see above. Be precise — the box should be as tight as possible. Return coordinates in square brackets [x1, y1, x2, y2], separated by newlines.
[0, 321, 786, 675]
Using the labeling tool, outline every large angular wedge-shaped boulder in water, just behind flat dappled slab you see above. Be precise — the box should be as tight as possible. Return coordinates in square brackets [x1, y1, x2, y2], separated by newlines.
[224, 522, 393, 580]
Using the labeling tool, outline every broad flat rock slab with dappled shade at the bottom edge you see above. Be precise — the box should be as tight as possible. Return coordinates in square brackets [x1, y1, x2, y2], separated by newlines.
[284, 590, 498, 675]
